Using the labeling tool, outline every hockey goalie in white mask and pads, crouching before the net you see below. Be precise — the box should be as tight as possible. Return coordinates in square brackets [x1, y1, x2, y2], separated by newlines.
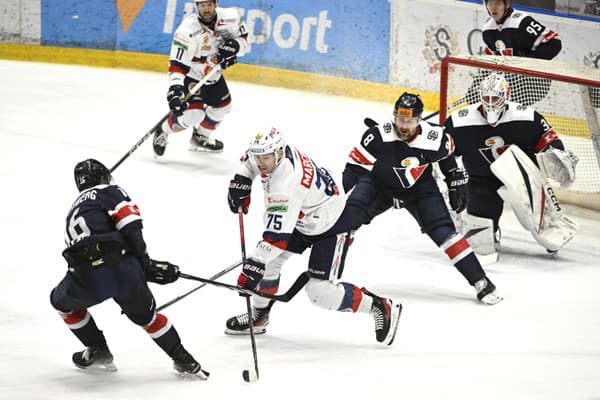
[444, 73, 578, 264]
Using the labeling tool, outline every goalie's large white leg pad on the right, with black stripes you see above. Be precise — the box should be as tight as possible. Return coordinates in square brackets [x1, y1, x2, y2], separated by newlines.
[490, 145, 577, 252]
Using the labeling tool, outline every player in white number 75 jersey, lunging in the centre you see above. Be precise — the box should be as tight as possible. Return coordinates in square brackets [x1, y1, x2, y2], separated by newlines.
[225, 128, 402, 345]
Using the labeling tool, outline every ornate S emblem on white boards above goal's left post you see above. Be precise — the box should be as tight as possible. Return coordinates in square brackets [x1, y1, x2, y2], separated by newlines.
[423, 25, 460, 74]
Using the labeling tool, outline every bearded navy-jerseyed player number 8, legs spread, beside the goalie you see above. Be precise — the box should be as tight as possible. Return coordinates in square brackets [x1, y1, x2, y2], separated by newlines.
[343, 93, 502, 304]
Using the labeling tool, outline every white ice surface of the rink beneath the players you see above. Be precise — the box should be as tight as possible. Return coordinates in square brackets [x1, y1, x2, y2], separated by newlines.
[0, 61, 600, 400]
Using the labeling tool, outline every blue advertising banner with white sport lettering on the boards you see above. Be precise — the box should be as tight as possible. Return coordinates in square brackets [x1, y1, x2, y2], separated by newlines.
[42, 0, 390, 83]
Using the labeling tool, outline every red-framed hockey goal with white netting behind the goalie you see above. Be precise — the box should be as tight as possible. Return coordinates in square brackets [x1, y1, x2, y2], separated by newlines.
[440, 56, 600, 210]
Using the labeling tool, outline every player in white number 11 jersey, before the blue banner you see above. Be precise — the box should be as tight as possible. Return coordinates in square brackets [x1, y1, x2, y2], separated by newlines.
[153, 0, 249, 157]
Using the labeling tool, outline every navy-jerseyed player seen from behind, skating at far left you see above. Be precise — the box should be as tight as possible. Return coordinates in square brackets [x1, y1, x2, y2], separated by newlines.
[50, 159, 208, 379]
